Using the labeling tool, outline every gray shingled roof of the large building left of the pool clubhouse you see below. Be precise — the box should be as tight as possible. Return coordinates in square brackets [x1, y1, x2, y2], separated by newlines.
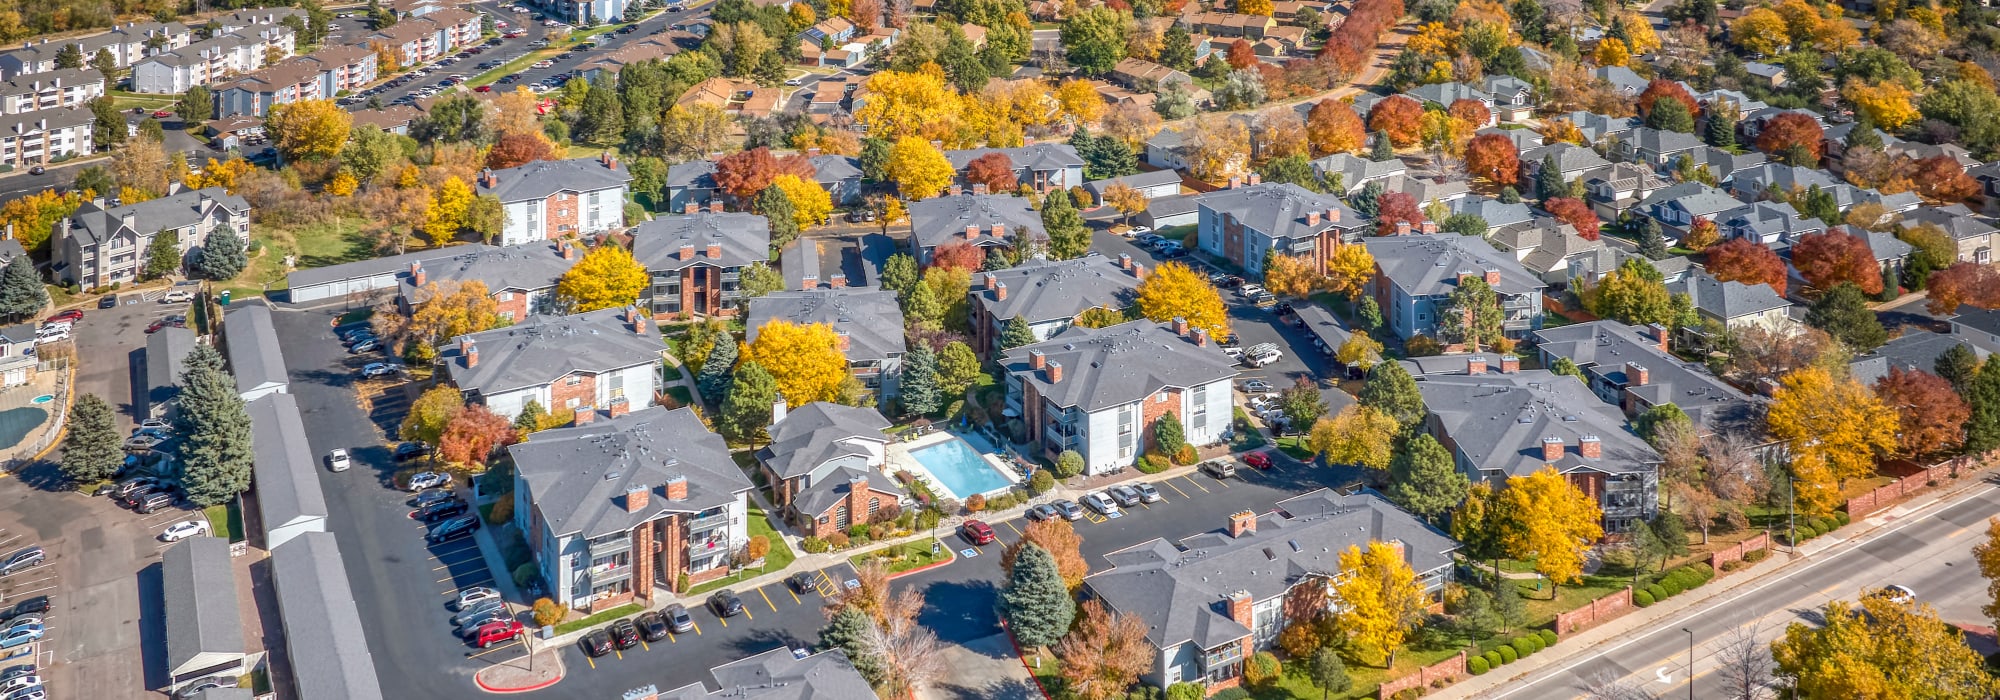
[508, 406, 752, 538]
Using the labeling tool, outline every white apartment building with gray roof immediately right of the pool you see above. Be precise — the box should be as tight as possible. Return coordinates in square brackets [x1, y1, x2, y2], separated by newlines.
[998, 320, 1236, 474]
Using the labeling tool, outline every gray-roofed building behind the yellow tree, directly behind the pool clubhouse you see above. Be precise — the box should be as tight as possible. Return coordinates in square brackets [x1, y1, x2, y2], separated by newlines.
[744, 286, 904, 398]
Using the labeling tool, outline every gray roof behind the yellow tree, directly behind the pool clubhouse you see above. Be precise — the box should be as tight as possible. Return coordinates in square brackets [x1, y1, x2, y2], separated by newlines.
[744, 286, 904, 360]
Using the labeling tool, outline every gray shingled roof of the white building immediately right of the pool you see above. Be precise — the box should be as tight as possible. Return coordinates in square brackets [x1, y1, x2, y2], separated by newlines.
[1000, 320, 1236, 410]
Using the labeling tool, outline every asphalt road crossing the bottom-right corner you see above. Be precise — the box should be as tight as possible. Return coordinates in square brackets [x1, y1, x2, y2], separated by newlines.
[1486, 480, 2000, 700]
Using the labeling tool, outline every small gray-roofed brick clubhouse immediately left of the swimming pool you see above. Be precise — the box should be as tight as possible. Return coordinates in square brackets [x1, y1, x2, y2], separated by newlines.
[756, 400, 906, 538]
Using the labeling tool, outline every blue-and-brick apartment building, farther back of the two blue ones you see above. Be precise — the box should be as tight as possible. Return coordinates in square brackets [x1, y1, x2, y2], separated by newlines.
[1194, 176, 1368, 276]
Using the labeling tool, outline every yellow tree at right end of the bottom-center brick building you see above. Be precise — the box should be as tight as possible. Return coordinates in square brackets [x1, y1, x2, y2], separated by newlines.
[1334, 540, 1428, 668]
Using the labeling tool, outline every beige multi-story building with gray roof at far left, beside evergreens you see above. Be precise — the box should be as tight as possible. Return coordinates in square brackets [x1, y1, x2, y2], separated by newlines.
[50, 188, 250, 288]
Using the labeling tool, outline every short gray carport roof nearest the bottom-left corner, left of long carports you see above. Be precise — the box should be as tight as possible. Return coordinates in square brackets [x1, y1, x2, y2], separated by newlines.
[160, 536, 248, 672]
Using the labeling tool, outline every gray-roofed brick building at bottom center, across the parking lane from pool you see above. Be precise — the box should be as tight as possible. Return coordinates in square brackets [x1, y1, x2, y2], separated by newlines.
[1084, 488, 1458, 686]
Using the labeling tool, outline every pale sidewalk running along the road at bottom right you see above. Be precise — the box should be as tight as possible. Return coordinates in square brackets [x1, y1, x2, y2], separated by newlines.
[1432, 470, 1992, 698]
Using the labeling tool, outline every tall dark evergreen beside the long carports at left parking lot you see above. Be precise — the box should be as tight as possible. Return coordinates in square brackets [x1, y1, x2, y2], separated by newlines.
[180, 344, 250, 508]
